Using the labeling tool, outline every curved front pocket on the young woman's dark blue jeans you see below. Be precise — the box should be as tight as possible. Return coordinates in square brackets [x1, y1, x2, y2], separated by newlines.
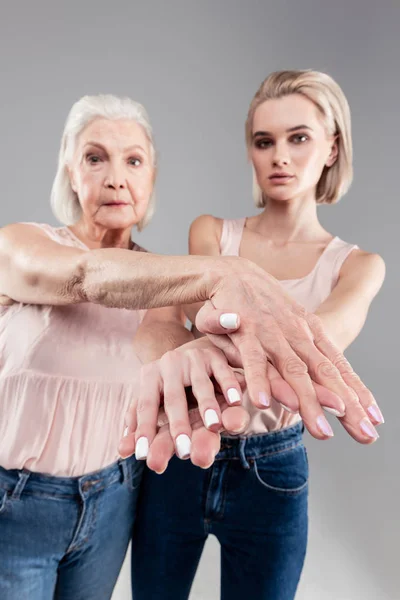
[253, 444, 308, 496]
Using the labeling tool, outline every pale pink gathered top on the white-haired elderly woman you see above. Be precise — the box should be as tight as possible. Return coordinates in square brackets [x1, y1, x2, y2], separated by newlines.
[0, 223, 146, 476]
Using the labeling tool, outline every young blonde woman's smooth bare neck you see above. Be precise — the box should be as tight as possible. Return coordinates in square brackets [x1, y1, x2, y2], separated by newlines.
[255, 191, 327, 243]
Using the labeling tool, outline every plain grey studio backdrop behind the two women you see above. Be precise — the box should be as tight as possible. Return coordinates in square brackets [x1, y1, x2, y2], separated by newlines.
[0, 0, 400, 600]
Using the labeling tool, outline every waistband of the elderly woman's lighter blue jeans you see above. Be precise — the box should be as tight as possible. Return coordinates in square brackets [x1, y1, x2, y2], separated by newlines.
[0, 456, 136, 498]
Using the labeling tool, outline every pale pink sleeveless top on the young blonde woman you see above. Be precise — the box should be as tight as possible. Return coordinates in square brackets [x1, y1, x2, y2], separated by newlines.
[220, 218, 358, 435]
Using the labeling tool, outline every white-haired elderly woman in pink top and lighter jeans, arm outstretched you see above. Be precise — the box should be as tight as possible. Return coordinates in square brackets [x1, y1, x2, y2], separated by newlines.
[0, 91, 382, 600]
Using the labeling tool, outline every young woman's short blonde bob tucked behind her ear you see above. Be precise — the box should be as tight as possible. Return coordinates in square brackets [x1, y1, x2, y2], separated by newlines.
[246, 70, 353, 208]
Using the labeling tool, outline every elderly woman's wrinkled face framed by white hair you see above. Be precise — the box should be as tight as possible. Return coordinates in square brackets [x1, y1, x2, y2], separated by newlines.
[69, 118, 154, 229]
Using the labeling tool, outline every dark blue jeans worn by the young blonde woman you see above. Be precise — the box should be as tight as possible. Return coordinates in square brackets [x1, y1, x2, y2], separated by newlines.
[132, 423, 308, 600]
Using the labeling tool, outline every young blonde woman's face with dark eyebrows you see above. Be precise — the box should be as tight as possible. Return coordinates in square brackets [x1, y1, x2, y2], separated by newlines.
[250, 94, 337, 201]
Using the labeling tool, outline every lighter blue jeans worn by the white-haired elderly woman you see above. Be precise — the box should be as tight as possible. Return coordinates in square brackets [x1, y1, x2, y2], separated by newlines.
[0, 458, 143, 600]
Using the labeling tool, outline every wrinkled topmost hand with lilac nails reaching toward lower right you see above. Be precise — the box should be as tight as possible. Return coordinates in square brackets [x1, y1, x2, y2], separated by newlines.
[196, 259, 379, 444]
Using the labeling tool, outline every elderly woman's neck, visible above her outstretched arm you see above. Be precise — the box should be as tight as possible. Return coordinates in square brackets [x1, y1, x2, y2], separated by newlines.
[69, 220, 133, 250]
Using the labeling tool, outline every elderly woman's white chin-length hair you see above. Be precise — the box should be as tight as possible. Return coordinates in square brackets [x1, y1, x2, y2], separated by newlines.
[51, 94, 157, 231]
